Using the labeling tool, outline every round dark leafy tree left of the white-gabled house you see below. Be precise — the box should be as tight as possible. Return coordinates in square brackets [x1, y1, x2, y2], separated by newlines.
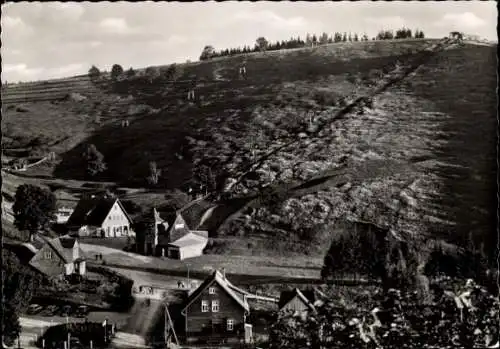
[12, 184, 56, 238]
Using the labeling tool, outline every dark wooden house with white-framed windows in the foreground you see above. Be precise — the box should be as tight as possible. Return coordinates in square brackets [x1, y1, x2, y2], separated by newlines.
[181, 271, 252, 344]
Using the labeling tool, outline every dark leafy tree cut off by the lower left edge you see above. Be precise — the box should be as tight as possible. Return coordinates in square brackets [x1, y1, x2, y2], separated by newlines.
[1, 249, 41, 345]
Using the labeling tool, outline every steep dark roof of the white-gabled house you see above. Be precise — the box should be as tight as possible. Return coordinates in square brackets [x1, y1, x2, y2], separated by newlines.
[66, 196, 132, 227]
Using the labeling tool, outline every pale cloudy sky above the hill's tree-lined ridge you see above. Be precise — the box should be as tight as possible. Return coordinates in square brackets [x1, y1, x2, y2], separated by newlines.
[1, 1, 497, 82]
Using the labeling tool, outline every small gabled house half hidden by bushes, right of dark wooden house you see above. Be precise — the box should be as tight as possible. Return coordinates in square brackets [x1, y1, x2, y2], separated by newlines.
[278, 288, 320, 315]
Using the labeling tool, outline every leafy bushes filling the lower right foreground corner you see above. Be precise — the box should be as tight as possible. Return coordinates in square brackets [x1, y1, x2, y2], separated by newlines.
[270, 280, 499, 349]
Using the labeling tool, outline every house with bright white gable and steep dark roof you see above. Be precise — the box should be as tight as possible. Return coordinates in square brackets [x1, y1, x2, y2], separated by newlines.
[66, 195, 135, 237]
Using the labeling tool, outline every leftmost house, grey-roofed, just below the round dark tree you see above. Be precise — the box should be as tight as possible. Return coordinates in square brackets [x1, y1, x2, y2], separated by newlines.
[29, 236, 86, 279]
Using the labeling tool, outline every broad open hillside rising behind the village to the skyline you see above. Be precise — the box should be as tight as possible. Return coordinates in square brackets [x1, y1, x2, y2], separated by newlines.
[2, 40, 496, 255]
